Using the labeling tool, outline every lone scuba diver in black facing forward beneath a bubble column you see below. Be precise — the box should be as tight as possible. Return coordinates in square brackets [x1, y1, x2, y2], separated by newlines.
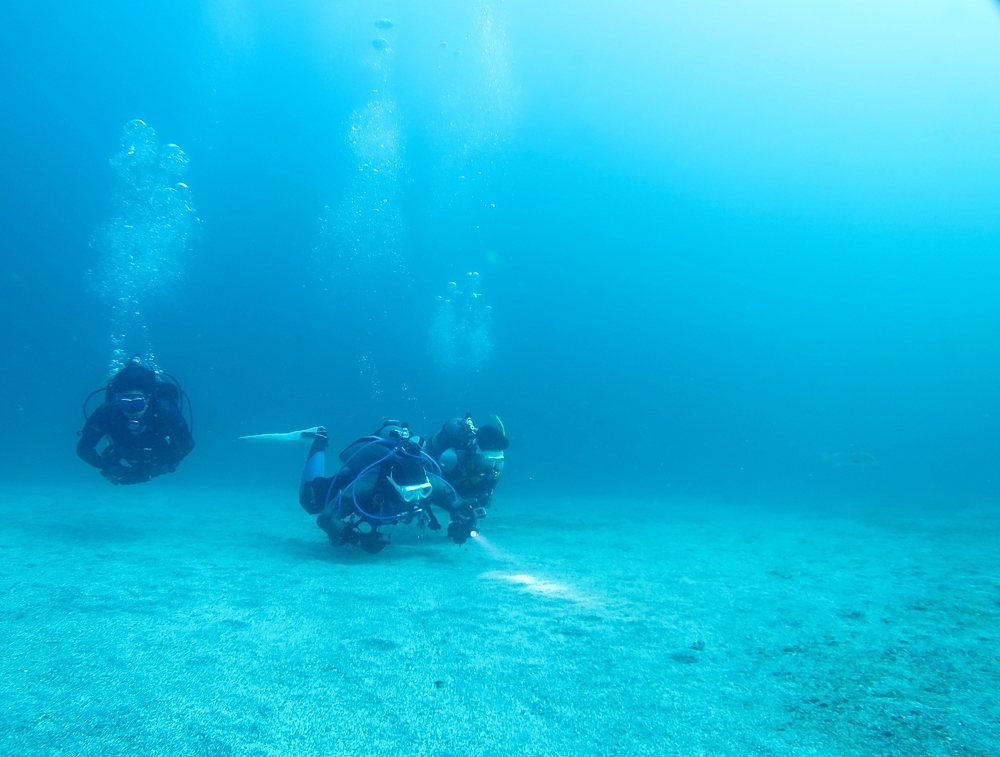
[76, 355, 194, 486]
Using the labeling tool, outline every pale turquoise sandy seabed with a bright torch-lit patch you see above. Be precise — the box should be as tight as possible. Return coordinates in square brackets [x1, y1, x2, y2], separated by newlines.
[0, 482, 1000, 757]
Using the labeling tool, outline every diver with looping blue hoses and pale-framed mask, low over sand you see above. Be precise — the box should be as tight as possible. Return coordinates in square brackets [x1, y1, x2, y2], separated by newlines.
[299, 421, 464, 554]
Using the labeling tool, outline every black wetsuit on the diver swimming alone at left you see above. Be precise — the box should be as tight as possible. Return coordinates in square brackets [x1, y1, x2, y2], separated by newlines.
[76, 396, 194, 484]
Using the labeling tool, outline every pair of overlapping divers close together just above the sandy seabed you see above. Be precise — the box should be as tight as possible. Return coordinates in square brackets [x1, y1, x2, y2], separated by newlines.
[262, 415, 510, 554]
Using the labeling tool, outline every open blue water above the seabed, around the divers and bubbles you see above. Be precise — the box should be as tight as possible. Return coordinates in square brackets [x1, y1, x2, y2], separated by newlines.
[0, 1, 1000, 503]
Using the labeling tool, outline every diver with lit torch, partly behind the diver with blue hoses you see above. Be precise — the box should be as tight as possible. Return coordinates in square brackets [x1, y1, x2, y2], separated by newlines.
[423, 413, 510, 544]
